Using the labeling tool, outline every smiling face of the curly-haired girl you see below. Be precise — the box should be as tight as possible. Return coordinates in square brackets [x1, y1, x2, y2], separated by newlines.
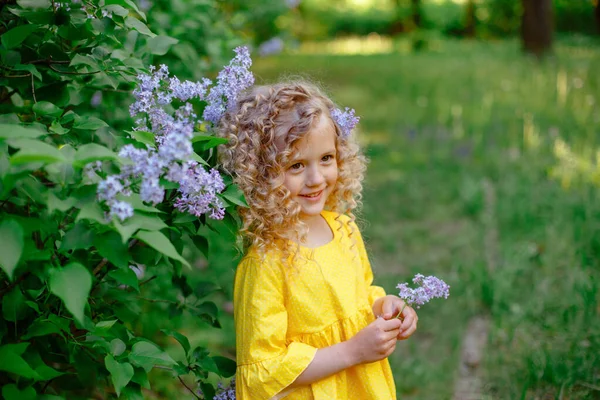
[284, 116, 338, 221]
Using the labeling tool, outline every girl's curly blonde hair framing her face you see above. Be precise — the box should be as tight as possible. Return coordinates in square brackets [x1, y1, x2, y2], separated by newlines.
[218, 81, 366, 253]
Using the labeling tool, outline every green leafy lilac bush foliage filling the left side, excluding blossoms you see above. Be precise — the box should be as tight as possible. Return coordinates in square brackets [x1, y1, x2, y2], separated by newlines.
[0, 0, 255, 400]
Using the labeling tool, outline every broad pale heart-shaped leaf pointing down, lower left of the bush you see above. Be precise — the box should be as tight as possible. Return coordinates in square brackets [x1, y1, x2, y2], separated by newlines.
[49, 263, 92, 325]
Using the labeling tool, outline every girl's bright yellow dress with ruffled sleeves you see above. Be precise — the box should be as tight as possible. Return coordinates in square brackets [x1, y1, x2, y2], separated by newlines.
[234, 211, 396, 400]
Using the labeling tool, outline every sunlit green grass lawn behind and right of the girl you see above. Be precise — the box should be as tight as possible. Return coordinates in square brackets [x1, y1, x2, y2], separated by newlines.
[191, 36, 600, 400]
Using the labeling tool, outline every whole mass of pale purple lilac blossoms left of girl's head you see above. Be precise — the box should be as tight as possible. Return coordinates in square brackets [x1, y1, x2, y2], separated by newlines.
[97, 48, 254, 221]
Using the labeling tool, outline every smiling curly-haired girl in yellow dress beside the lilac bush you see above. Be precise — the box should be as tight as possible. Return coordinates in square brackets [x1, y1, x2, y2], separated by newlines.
[220, 82, 417, 400]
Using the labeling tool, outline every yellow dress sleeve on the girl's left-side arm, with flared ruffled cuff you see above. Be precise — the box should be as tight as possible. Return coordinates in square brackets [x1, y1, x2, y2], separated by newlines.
[234, 258, 317, 400]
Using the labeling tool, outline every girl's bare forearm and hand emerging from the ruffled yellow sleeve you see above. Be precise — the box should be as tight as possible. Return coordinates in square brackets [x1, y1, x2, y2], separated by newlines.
[287, 318, 402, 389]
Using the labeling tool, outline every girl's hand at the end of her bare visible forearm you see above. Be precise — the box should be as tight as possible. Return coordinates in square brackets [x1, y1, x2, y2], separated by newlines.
[347, 318, 402, 364]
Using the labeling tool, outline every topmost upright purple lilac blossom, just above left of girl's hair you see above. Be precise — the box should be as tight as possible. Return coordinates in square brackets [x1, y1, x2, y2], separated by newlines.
[203, 47, 254, 124]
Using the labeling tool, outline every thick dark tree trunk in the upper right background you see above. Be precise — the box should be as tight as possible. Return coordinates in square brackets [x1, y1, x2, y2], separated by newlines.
[521, 0, 553, 57]
